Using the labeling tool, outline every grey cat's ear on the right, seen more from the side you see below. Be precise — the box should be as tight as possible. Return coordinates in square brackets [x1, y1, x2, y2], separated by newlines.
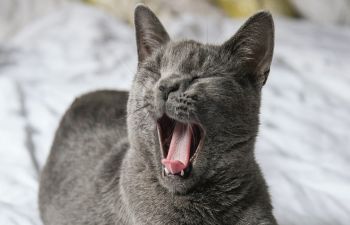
[221, 11, 274, 86]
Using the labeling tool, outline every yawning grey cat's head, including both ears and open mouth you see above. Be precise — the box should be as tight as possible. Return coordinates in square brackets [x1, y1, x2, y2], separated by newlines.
[128, 5, 274, 193]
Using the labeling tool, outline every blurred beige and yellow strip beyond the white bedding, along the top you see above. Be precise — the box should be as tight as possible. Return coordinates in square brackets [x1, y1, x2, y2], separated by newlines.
[0, 0, 350, 40]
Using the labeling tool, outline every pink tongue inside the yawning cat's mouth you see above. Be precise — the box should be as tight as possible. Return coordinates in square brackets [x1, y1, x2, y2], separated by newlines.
[162, 123, 192, 174]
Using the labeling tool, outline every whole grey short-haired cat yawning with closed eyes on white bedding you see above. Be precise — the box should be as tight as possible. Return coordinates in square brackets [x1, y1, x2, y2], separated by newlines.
[39, 5, 277, 225]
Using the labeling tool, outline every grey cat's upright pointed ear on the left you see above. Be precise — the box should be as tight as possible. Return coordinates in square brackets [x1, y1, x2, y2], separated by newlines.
[134, 4, 170, 62]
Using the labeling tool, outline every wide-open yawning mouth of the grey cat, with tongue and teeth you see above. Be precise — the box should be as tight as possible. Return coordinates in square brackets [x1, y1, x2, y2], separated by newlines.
[157, 114, 204, 177]
